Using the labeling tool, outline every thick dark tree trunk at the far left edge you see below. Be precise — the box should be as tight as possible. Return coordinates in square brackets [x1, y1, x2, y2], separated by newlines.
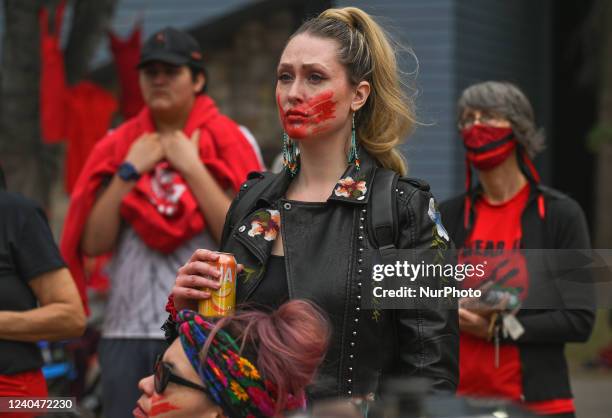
[0, 0, 57, 207]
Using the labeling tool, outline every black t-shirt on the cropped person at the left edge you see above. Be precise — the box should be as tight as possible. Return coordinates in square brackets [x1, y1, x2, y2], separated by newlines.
[0, 190, 65, 375]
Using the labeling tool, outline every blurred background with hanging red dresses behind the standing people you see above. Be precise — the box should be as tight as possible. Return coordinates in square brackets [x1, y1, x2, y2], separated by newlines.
[0, 0, 612, 418]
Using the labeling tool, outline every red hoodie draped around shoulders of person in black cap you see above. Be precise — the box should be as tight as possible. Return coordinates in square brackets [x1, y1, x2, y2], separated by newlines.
[60, 95, 262, 310]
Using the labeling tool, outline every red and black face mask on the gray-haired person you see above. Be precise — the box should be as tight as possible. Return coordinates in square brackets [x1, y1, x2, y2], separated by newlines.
[461, 125, 516, 170]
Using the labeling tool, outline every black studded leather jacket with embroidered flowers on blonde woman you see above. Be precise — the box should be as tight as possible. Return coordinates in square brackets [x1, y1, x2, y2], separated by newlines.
[221, 155, 459, 397]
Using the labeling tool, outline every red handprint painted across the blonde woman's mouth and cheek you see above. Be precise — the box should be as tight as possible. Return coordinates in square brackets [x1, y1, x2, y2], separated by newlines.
[276, 90, 336, 139]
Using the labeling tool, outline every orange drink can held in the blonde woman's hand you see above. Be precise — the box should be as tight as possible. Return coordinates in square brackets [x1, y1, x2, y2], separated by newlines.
[198, 253, 238, 317]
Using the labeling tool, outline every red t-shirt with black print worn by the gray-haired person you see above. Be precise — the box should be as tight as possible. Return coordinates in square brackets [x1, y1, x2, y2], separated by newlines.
[458, 184, 574, 414]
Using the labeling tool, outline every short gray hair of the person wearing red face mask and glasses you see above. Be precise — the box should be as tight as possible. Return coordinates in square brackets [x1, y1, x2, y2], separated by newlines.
[457, 81, 545, 158]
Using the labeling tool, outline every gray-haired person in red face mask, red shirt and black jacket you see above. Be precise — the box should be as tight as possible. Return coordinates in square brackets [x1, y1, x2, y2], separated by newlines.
[440, 81, 594, 417]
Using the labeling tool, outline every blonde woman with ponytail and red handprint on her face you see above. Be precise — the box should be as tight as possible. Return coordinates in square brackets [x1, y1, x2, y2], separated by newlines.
[167, 7, 458, 399]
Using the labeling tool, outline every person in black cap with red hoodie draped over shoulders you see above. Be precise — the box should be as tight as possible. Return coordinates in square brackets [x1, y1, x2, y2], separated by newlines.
[62, 28, 262, 418]
